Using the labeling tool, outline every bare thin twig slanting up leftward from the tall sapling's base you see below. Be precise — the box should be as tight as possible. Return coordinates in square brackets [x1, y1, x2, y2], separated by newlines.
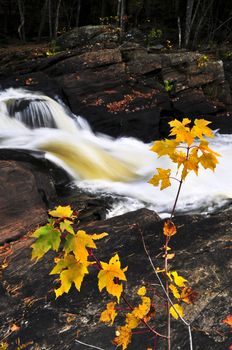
[139, 224, 193, 350]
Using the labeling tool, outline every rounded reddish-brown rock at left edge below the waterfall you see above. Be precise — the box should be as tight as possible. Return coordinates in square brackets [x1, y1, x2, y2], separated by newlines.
[0, 160, 55, 243]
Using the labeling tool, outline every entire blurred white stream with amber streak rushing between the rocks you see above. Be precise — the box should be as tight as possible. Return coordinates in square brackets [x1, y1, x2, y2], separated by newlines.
[0, 89, 232, 216]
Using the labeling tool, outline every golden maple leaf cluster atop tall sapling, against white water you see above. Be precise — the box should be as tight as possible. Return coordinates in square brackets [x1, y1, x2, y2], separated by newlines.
[149, 118, 219, 190]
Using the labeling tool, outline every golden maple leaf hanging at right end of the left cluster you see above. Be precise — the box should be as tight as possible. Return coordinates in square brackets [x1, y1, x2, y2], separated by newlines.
[98, 254, 127, 302]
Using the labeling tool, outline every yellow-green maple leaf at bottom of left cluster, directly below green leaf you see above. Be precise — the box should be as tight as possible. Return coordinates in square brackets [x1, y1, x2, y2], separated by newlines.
[50, 254, 89, 298]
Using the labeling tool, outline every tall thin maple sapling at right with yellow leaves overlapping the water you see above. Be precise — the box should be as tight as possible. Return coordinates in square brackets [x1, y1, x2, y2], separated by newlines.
[149, 118, 220, 350]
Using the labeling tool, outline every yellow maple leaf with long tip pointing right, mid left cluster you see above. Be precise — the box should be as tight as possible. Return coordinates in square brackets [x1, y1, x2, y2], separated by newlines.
[64, 230, 108, 263]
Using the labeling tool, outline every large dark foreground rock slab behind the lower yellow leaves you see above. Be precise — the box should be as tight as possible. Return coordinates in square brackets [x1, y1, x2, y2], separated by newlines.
[0, 209, 232, 350]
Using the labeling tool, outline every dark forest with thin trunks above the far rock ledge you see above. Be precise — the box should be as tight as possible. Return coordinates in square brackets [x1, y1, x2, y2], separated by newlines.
[0, 0, 232, 48]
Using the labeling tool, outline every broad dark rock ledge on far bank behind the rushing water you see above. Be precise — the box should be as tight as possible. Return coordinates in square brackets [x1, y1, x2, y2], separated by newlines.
[0, 34, 232, 142]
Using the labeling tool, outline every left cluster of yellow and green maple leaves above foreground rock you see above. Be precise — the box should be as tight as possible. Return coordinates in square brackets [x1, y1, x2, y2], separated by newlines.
[32, 206, 127, 302]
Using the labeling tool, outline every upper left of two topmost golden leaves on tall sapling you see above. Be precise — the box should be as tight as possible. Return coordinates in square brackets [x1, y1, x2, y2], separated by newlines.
[169, 118, 194, 146]
